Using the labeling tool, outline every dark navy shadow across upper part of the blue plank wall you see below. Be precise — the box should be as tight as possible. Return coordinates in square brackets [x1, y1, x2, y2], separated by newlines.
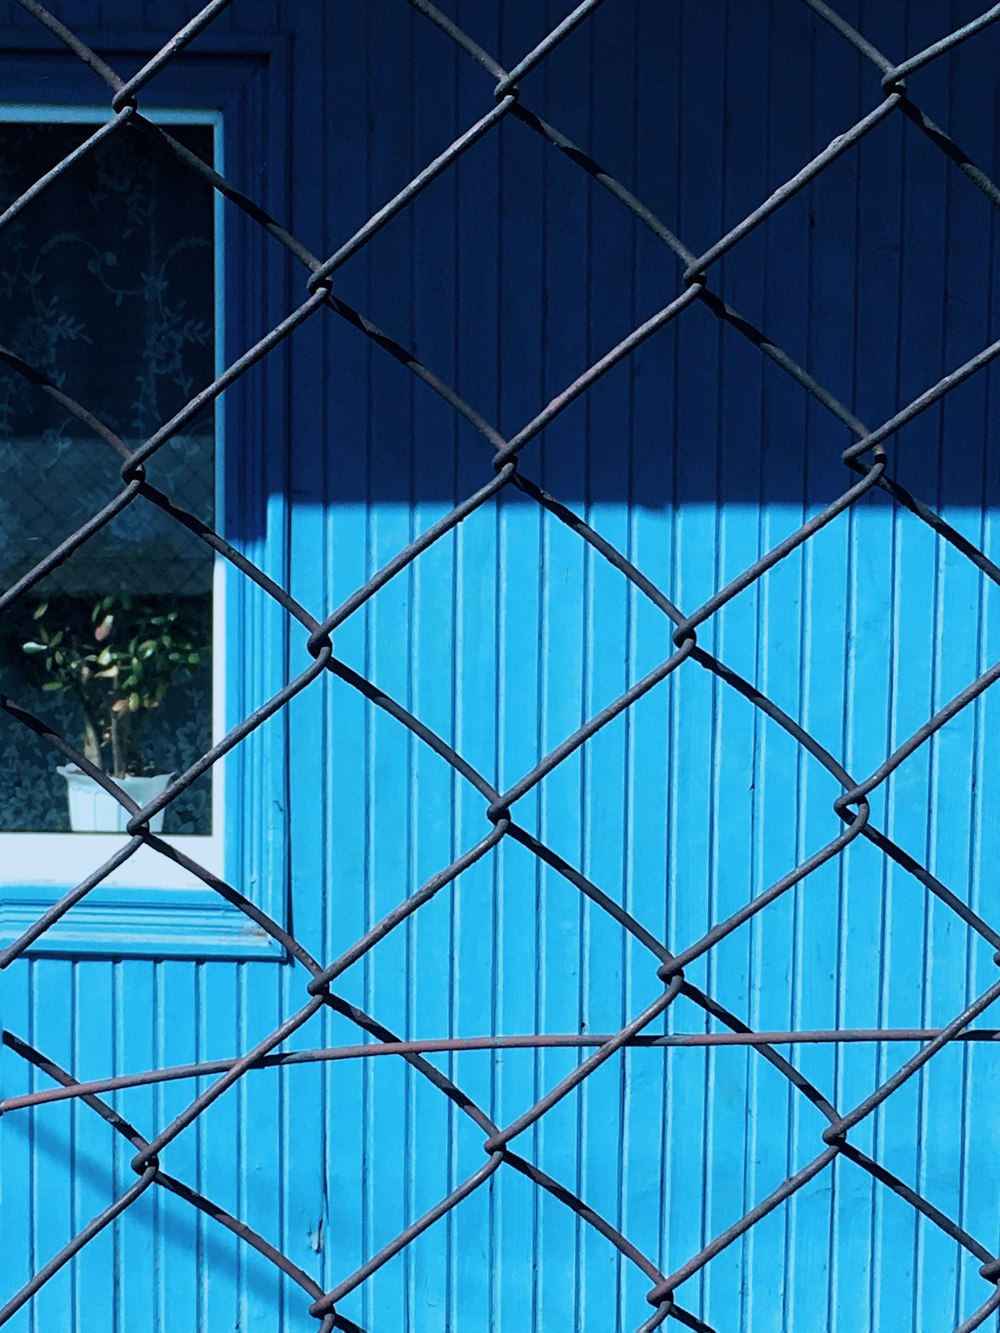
[266, 3, 1000, 509]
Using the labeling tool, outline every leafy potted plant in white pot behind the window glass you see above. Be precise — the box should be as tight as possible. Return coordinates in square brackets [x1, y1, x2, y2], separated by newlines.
[21, 593, 208, 832]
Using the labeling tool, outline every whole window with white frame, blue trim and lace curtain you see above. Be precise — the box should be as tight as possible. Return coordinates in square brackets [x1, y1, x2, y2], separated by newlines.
[0, 46, 292, 957]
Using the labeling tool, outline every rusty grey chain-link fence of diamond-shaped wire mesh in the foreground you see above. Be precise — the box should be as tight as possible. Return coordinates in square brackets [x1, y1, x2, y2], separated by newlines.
[0, 0, 1000, 1333]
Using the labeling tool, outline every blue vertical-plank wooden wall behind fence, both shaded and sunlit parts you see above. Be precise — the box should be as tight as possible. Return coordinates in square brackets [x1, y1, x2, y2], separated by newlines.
[0, 0, 1000, 1333]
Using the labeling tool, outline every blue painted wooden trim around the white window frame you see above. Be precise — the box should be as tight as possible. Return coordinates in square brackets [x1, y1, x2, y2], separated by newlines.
[0, 32, 291, 961]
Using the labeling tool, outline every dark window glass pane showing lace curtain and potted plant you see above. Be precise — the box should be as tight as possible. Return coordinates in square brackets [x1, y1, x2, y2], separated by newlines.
[0, 121, 215, 834]
